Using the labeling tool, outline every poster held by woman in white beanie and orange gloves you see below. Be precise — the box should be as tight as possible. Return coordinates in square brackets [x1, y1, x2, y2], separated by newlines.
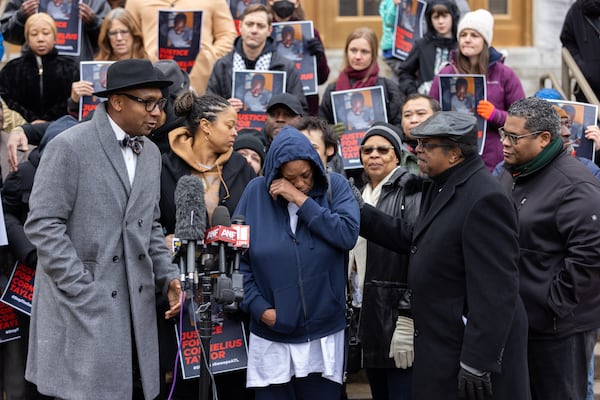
[438, 74, 487, 154]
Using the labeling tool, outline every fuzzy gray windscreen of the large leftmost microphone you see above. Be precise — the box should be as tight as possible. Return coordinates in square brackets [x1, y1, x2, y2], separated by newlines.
[174, 175, 206, 240]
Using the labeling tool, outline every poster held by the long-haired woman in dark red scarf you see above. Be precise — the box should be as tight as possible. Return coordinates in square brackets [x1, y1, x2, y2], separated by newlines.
[331, 86, 387, 169]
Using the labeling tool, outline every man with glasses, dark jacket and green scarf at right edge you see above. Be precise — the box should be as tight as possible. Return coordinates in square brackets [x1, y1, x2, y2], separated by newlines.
[499, 97, 600, 400]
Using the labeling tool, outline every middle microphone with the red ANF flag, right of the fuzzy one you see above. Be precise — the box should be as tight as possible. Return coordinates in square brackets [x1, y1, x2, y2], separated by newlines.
[210, 206, 237, 304]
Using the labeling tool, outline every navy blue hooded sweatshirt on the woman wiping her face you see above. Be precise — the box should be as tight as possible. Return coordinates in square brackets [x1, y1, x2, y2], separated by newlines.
[235, 126, 360, 343]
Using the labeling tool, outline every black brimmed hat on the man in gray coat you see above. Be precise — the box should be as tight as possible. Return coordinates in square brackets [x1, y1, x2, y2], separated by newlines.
[94, 59, 173, 97]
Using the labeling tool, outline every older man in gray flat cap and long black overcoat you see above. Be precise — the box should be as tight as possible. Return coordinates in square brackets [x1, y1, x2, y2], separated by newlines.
[360, 111, 530, 400]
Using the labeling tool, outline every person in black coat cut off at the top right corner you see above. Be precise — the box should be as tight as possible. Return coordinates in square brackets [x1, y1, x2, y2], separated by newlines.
[560, 0, 600, 103]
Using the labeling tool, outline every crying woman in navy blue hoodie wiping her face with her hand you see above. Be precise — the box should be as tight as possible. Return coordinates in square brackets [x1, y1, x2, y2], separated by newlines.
[236, 126, 360, 400]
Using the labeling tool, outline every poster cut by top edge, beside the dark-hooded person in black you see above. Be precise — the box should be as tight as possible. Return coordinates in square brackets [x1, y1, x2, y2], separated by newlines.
[393, 0, 427, 60]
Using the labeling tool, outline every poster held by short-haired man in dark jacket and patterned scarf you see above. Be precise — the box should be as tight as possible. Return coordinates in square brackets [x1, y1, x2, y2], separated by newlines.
[231, 70, 286, 130]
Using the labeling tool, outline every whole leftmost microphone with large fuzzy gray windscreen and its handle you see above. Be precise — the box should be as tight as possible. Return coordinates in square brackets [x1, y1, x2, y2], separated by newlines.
[174, 175, 206, 287]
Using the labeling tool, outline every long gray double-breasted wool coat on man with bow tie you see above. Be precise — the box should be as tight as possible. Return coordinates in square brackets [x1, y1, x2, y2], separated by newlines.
[25, 104, 178, 400]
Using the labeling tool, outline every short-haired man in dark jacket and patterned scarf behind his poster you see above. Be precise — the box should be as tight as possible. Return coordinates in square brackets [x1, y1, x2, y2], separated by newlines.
[206, 4, 308, 111]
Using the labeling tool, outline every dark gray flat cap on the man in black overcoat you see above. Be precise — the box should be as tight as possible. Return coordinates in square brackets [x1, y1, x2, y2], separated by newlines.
[410, 111, 477, 145]
